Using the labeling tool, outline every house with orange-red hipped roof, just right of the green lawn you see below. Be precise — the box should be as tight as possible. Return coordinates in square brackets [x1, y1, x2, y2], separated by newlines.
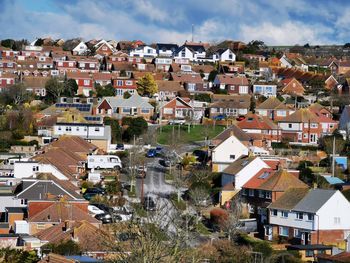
[237, 113, 282, 147]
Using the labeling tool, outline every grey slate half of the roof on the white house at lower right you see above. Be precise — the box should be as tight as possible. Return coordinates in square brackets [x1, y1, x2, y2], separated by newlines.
[293, 189, 337, 213]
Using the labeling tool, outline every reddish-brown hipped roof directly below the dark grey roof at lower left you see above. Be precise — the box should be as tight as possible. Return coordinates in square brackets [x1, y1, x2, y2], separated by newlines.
[28, 201, 99, 224]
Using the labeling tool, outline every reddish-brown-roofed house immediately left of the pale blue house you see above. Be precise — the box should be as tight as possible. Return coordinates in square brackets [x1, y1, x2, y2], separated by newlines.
[213, 74, 249, 94]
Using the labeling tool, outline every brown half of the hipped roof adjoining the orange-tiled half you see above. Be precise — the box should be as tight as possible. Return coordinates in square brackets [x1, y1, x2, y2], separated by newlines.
[258, 170, 308, 192]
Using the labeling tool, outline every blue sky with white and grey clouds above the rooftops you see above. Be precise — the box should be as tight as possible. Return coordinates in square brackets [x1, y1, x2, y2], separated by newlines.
[0, 0, 350, 45]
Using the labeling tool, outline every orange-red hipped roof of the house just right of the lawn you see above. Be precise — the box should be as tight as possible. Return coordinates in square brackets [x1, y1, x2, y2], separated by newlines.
[237, 113, 278, 130]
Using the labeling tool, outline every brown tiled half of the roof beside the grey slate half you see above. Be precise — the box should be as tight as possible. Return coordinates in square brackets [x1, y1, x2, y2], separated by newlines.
[268, 188, 309, 210]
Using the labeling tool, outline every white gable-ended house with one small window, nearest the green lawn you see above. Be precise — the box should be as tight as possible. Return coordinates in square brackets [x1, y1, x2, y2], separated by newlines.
[212, 135, 249, 172]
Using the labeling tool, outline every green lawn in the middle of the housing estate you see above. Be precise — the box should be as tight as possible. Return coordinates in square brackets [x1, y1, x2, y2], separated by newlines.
[158, 125, 225, 145]
